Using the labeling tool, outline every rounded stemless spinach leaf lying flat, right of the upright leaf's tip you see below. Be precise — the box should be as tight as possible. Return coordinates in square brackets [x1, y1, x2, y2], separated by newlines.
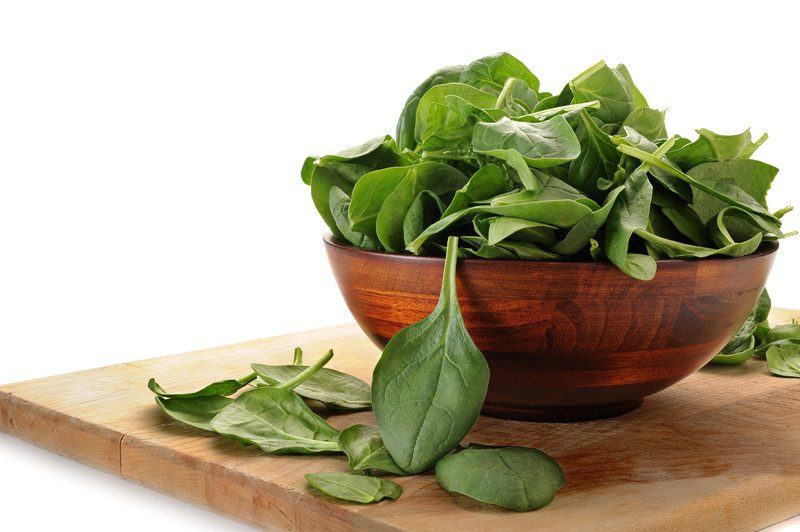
[436, 444, 564, 512]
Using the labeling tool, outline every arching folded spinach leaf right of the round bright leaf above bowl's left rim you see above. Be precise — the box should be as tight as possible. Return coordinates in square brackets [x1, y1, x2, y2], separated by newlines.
[375, 162, 467, 251]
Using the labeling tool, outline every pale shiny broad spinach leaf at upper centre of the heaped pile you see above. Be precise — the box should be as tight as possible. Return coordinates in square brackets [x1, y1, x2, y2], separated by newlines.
[472, 116, 581, 168]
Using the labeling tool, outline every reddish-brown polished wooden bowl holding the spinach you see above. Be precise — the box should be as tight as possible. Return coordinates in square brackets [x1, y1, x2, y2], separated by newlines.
[325, 236, 778, 421]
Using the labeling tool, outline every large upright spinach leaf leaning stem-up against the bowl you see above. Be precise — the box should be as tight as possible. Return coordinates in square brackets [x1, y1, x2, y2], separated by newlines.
[372, 237, 489, 474]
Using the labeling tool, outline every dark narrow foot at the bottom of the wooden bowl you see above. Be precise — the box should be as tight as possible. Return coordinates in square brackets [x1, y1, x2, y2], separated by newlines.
[481, 397, 644, 421]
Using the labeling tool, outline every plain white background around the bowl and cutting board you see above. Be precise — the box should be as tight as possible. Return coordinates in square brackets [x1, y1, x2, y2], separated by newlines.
[0, 0, 800, 530]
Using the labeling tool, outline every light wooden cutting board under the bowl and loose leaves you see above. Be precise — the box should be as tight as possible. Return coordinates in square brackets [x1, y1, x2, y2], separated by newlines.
[0, 310, 800, 531]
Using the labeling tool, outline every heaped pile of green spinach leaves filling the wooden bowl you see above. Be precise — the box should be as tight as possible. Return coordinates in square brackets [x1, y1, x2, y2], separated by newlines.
[301, 53, 790, 280]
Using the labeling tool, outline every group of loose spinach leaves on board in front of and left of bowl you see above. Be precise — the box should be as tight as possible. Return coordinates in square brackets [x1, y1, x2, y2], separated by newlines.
[148, 247, 564, 511]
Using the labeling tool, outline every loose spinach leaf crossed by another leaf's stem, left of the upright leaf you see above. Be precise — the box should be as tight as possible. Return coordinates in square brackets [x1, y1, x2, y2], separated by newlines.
[252, 358, 372, 412]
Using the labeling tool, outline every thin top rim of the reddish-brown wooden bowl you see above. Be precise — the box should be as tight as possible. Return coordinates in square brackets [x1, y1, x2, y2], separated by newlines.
[322, 232, 780, 269]
